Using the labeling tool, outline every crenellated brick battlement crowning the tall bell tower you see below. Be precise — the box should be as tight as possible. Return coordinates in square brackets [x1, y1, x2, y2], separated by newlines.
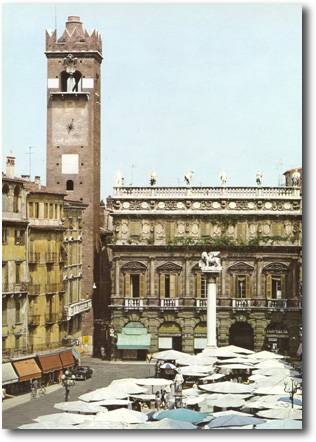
[46, 16, 102, 54]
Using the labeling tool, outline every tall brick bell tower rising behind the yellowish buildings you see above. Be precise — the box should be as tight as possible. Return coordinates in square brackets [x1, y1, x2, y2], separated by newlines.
[45, 16, 102, 351]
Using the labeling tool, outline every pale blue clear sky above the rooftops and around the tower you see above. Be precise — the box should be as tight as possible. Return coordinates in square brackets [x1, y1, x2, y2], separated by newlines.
[2, 3, 302, 199]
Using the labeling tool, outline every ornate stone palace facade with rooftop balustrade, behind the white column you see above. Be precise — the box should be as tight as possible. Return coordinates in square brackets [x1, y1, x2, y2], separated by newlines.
[103, 181, 302, 359]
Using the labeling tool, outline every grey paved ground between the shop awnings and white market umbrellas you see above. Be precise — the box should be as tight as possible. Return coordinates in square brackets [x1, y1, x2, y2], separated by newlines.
[2, 357, 155, 430]
